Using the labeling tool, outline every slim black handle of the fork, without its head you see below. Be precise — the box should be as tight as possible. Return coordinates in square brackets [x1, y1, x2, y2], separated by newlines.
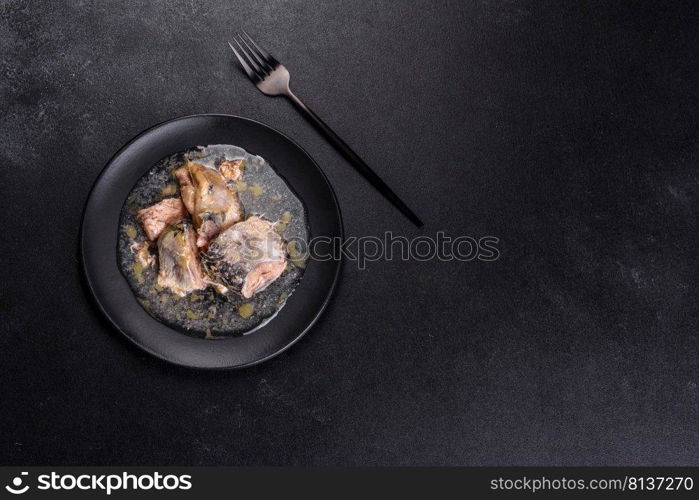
[286, 91, 423, 227]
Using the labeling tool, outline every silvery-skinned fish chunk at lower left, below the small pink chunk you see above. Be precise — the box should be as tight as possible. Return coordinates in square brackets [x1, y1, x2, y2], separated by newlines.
[158, 220, 206, 297]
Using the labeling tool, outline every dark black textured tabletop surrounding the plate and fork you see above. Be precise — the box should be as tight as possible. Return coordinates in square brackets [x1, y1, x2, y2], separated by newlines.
[0, 0, 699, 465]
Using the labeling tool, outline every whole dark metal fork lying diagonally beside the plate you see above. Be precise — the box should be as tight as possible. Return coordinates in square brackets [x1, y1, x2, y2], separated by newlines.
[228, 31, 423, 227]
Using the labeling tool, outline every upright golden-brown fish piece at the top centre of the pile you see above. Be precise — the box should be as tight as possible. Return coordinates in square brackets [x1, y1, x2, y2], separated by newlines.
[174, 161, 243, 248]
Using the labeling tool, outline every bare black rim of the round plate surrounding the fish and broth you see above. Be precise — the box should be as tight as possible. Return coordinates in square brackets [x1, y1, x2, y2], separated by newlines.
[81, 115, 343, 368]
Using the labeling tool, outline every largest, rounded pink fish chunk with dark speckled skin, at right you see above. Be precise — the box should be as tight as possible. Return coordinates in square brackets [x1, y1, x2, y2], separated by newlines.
[202, 215, 287, 299]
